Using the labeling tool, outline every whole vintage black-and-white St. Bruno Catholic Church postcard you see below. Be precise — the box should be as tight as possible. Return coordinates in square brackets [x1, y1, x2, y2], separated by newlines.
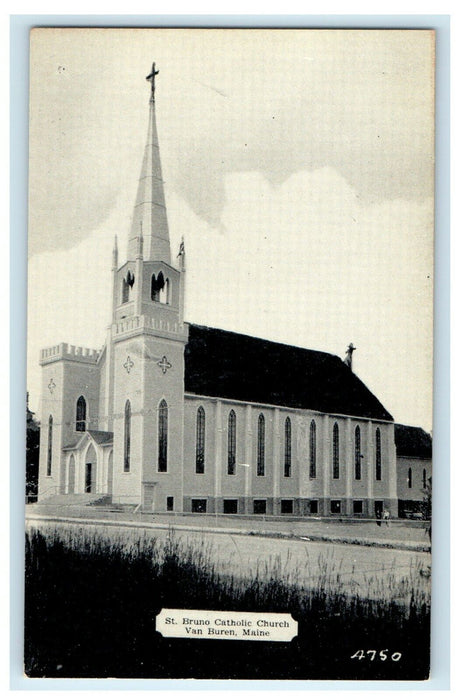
[24, 28, 435, 680]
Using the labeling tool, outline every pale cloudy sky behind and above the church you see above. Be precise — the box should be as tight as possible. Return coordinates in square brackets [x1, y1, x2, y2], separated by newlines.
[28, 29, 434, 430]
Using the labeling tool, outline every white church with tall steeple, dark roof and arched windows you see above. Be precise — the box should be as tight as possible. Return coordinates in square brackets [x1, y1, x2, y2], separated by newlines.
[39, 64, 398, 517]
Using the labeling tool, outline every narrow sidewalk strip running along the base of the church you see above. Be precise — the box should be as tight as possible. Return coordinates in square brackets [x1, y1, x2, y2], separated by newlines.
[26, 504, 430, 552]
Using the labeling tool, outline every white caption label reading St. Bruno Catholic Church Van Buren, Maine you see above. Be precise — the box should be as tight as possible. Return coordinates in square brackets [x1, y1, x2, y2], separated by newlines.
[156, 608, 298, 642]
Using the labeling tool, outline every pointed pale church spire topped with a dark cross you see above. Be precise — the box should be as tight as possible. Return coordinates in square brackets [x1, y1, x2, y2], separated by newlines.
[128, 64, 171, 264]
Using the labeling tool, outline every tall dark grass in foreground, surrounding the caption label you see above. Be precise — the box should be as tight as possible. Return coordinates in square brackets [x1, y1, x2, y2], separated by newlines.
[25, 526, 430, 680]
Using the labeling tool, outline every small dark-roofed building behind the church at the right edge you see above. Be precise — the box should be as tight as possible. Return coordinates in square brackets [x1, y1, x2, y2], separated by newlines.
[395, 423, 432, 518]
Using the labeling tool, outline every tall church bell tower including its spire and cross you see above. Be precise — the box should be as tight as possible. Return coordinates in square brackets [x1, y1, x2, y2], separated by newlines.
[110, 64, 187, 510]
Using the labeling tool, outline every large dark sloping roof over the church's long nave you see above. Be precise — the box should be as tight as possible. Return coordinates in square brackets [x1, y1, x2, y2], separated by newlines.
[185, 324, 393, 421]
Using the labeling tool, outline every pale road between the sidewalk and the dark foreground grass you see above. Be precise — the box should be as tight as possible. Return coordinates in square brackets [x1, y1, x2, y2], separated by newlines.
[28, 518, 430, 599]
